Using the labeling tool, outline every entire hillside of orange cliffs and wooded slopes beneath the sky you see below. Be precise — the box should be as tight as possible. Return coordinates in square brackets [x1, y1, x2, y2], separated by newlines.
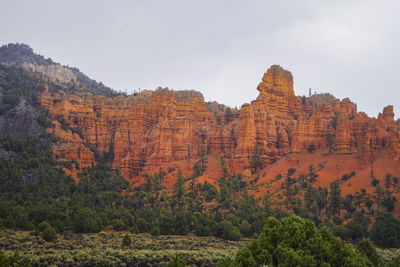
[0, 44, 400, 254]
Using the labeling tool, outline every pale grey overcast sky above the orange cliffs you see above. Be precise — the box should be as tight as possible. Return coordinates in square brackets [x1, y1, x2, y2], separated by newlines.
[0, 0, 400, 118]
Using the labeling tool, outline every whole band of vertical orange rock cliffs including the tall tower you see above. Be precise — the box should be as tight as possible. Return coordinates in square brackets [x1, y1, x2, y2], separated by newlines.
[41, 65, 400, 182]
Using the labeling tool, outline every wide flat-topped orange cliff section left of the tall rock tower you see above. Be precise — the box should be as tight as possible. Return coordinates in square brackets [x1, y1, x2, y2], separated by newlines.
[41, 89, 237, 178]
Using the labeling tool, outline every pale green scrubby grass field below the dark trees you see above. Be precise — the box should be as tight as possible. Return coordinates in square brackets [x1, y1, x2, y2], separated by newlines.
[0, 230, 246, 266]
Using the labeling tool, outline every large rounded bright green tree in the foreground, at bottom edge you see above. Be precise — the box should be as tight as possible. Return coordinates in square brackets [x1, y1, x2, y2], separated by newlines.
[228, 215, 373, 267]
